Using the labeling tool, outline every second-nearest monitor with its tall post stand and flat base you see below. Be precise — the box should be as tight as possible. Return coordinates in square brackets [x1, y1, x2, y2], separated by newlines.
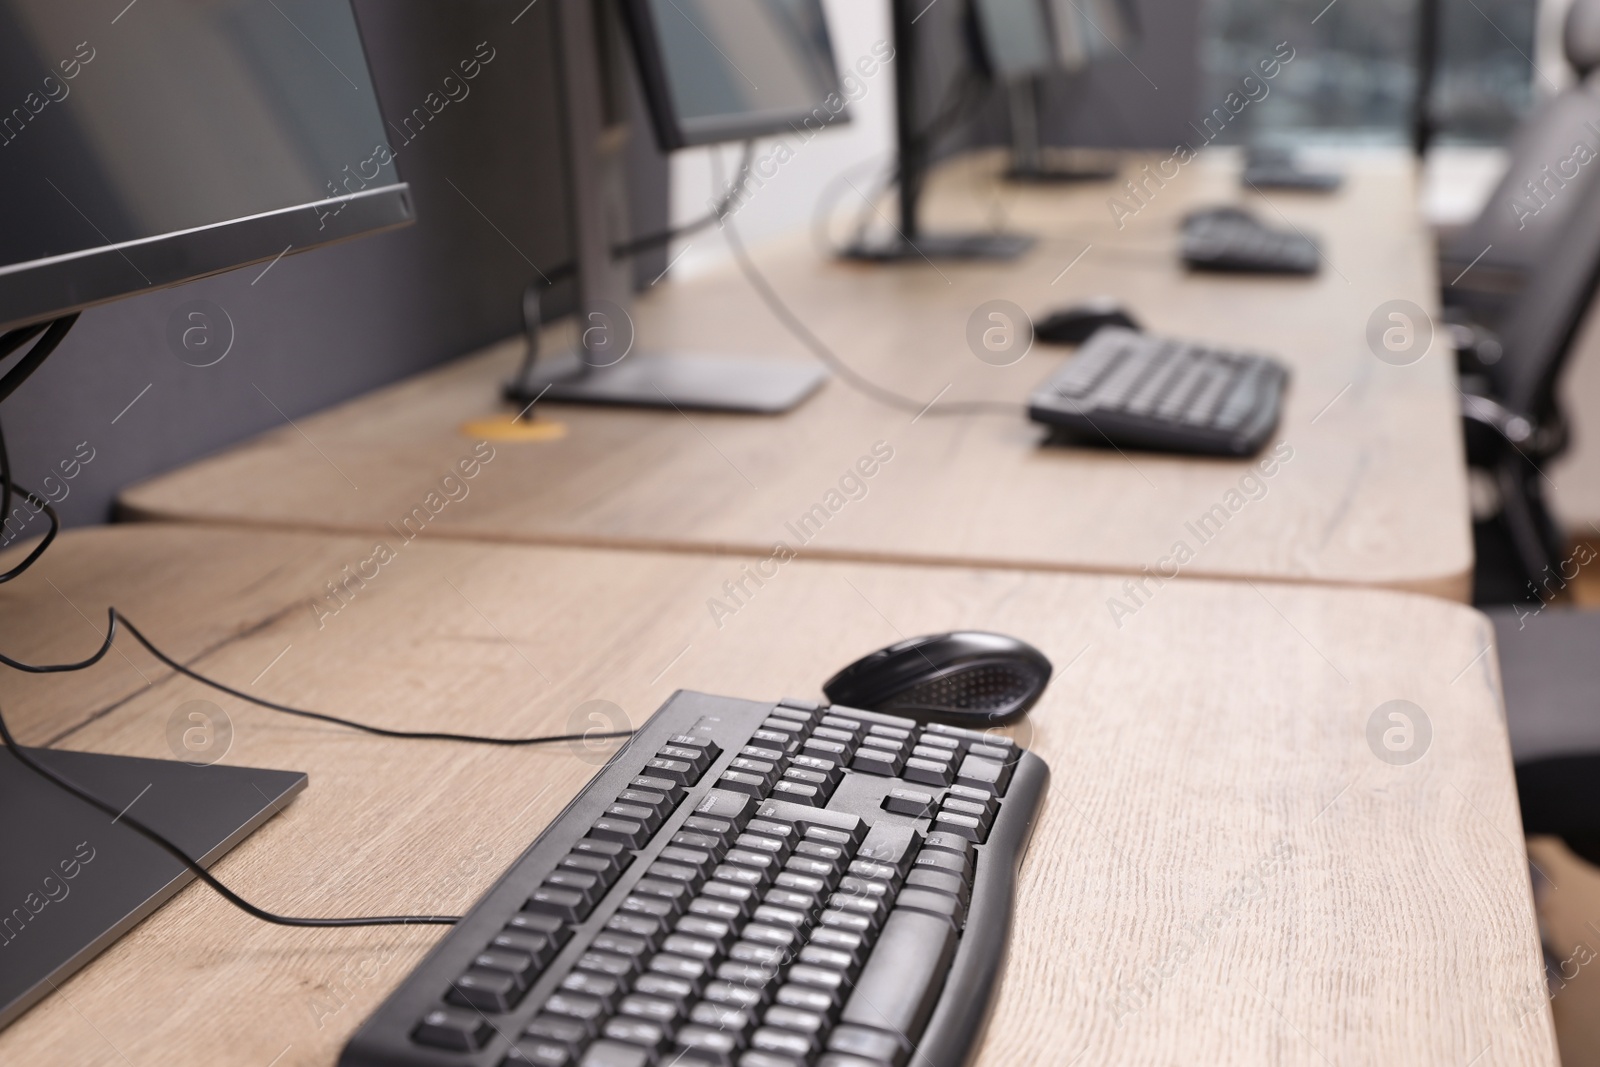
[506, 0, 848, 414]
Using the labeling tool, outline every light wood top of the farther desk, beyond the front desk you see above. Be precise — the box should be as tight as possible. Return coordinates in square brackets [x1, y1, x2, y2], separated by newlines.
[122, 152, 1472, 600]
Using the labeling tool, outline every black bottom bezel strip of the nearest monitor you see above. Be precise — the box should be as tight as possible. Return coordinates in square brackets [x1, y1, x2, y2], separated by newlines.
[0, 182, 416, 331]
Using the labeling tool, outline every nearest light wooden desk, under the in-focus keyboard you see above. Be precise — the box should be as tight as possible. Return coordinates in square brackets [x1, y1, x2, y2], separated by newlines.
[0, 525, 1555, 1067]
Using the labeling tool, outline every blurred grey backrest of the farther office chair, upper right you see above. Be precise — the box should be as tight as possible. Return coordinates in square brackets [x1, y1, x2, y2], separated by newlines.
[1438, 0, 1600, 328]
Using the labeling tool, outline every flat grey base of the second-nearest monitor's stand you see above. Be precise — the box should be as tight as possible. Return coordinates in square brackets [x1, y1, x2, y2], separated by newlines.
[506, 352, 827, 414]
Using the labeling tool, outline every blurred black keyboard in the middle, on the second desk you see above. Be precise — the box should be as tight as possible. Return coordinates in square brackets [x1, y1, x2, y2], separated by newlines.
[1027, 326, 1288, 456]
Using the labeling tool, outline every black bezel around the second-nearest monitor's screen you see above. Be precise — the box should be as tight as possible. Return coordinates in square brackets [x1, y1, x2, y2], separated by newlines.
[619, 0, 850, 152]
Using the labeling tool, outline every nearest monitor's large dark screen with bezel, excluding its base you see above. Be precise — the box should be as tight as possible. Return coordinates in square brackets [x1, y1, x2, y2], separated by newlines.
[0, 0, 410, 325]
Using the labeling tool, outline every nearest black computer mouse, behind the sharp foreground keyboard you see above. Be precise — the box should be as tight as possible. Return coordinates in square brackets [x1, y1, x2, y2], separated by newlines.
[822, 630, 1051, 729]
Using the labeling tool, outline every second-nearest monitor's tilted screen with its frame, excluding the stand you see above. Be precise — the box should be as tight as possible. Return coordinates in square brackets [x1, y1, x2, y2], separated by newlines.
[626, 0, 845, 150]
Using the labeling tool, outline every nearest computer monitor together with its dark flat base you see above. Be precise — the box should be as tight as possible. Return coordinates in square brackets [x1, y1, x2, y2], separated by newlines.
[0, 0, 411, 1027]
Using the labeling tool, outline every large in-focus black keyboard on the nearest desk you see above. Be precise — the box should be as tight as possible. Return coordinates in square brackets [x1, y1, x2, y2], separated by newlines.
[339, 693, 1050, 1067]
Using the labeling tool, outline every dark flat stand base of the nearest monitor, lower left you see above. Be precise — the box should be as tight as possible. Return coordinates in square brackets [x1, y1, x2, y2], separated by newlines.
[0, 747, 306, 1029]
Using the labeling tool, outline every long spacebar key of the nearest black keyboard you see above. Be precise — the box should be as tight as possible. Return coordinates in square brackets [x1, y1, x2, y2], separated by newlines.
[842, 909, 955, 1045]
